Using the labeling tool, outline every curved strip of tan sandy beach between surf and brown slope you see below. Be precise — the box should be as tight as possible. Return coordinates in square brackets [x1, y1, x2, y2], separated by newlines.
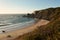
[0, 19, 49, 40]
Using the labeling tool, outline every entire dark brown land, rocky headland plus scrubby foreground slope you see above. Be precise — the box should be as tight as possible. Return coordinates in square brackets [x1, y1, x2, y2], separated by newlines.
[14, 7, 60, 40]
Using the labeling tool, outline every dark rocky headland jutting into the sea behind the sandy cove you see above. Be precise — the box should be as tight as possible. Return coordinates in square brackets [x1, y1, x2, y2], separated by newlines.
[26, 7, 60, 20]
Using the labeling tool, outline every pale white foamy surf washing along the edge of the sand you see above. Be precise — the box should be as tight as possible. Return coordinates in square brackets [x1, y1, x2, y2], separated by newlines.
[0, 20, 35, 33]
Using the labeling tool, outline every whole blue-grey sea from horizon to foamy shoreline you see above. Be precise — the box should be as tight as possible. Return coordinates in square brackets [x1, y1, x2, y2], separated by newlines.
[0, 14, 35, 33]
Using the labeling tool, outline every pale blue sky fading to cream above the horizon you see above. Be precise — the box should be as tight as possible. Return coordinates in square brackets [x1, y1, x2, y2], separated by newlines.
[0, 0, 60, 14]
